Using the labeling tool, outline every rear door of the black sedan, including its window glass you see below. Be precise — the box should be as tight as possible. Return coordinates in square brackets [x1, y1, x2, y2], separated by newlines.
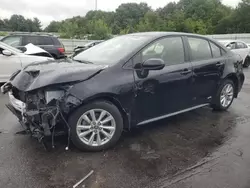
[186, 37, 226, 105]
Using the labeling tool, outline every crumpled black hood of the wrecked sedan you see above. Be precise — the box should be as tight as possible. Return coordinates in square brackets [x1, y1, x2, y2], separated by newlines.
[11, 59, 107, 91]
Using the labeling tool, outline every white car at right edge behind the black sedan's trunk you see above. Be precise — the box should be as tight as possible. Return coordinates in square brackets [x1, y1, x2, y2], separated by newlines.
[219, 40, 250, 67]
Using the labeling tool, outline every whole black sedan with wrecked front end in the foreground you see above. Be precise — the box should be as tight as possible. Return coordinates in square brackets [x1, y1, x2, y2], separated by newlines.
[1, 32, 245, 151]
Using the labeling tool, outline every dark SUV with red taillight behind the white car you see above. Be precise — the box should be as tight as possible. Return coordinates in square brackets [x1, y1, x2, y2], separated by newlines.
[1, 33, 65, 59]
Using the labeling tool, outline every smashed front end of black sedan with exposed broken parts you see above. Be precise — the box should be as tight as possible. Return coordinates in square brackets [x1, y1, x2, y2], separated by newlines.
[1, 83, 81, 149]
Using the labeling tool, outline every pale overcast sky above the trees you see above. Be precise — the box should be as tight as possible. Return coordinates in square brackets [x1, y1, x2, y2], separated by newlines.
[0, 0, 240, 26]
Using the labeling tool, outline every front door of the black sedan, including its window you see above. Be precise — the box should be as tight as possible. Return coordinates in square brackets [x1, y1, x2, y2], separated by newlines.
[133, 36, 193, 124]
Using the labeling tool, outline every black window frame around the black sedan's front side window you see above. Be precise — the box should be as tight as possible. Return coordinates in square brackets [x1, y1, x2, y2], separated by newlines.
[131, 35, 189, 69]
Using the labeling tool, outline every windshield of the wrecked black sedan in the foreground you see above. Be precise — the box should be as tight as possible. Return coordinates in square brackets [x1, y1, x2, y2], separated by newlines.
[74, 35, 148, 64]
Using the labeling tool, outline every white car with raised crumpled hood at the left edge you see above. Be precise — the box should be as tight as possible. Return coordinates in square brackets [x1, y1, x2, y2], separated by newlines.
[0, 42, 53, 83]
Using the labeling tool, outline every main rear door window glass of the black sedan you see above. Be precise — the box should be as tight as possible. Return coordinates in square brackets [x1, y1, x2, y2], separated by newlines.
[188, 37, 212, 61]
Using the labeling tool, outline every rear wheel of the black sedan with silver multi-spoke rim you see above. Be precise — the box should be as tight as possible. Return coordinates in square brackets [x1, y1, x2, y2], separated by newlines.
[212, 79, 235, 111]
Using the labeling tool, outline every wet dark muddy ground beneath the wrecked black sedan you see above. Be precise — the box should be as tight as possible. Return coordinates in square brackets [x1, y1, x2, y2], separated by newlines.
[0, 69, 250, 188]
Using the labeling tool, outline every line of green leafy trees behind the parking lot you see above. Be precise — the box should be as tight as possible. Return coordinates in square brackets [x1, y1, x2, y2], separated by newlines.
[0, 0, 250, 39]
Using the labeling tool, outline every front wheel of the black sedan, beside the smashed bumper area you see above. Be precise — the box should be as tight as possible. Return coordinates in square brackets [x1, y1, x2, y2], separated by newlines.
[69, 101, 123, 151]
